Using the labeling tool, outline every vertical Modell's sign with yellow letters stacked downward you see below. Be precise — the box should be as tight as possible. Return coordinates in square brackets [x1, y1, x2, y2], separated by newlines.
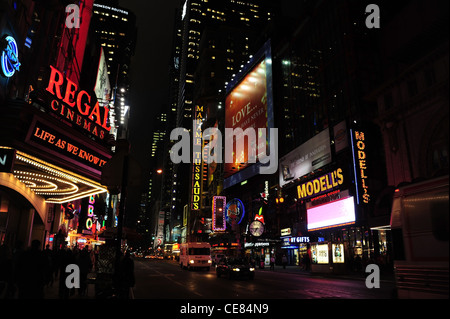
[352, 130, 370, 204]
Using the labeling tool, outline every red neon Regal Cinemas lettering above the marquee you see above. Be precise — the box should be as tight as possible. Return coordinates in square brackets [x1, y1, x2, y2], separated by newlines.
[45, 66, 111, 139]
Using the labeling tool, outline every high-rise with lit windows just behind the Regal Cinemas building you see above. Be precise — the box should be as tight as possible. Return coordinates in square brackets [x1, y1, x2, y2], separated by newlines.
[92, 0, 137, 138]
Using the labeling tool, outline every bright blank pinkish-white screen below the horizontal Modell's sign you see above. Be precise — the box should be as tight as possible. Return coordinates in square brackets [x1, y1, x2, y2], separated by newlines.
[306, 196, 355, 231]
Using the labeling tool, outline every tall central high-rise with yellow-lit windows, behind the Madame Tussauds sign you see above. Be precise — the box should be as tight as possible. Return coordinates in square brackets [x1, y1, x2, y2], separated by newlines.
[167, 0, 276, 244]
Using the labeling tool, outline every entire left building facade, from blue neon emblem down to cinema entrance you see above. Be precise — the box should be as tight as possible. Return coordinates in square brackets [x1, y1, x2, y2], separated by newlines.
[0, 0, 132, 252]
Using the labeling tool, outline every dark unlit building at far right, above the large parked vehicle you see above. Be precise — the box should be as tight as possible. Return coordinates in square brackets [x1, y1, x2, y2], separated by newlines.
[370, 1, 449, 186]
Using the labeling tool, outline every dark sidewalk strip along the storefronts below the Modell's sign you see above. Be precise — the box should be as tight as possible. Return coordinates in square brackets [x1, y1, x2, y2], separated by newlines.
[256, 265, 395, 282]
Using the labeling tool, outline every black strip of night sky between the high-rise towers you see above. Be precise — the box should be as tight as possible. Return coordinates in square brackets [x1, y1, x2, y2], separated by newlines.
[120, 0, 180, 223]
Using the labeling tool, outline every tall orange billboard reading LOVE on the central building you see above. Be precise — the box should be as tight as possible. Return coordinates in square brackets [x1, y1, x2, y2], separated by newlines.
[224, 42, 273, 188]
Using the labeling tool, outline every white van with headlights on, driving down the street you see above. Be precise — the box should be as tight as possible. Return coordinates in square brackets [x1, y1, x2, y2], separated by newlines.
[180, 242, 212, 270]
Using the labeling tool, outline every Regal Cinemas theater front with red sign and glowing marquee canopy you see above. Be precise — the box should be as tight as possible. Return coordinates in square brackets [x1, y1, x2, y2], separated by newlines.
[0, 60, 112, 248]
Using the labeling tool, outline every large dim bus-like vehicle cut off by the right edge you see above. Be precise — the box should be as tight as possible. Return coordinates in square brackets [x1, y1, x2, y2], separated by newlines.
[391, 175, 449, 299]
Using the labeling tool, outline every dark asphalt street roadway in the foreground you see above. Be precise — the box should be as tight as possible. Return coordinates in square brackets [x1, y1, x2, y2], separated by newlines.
[134, 258, 394, 300]
